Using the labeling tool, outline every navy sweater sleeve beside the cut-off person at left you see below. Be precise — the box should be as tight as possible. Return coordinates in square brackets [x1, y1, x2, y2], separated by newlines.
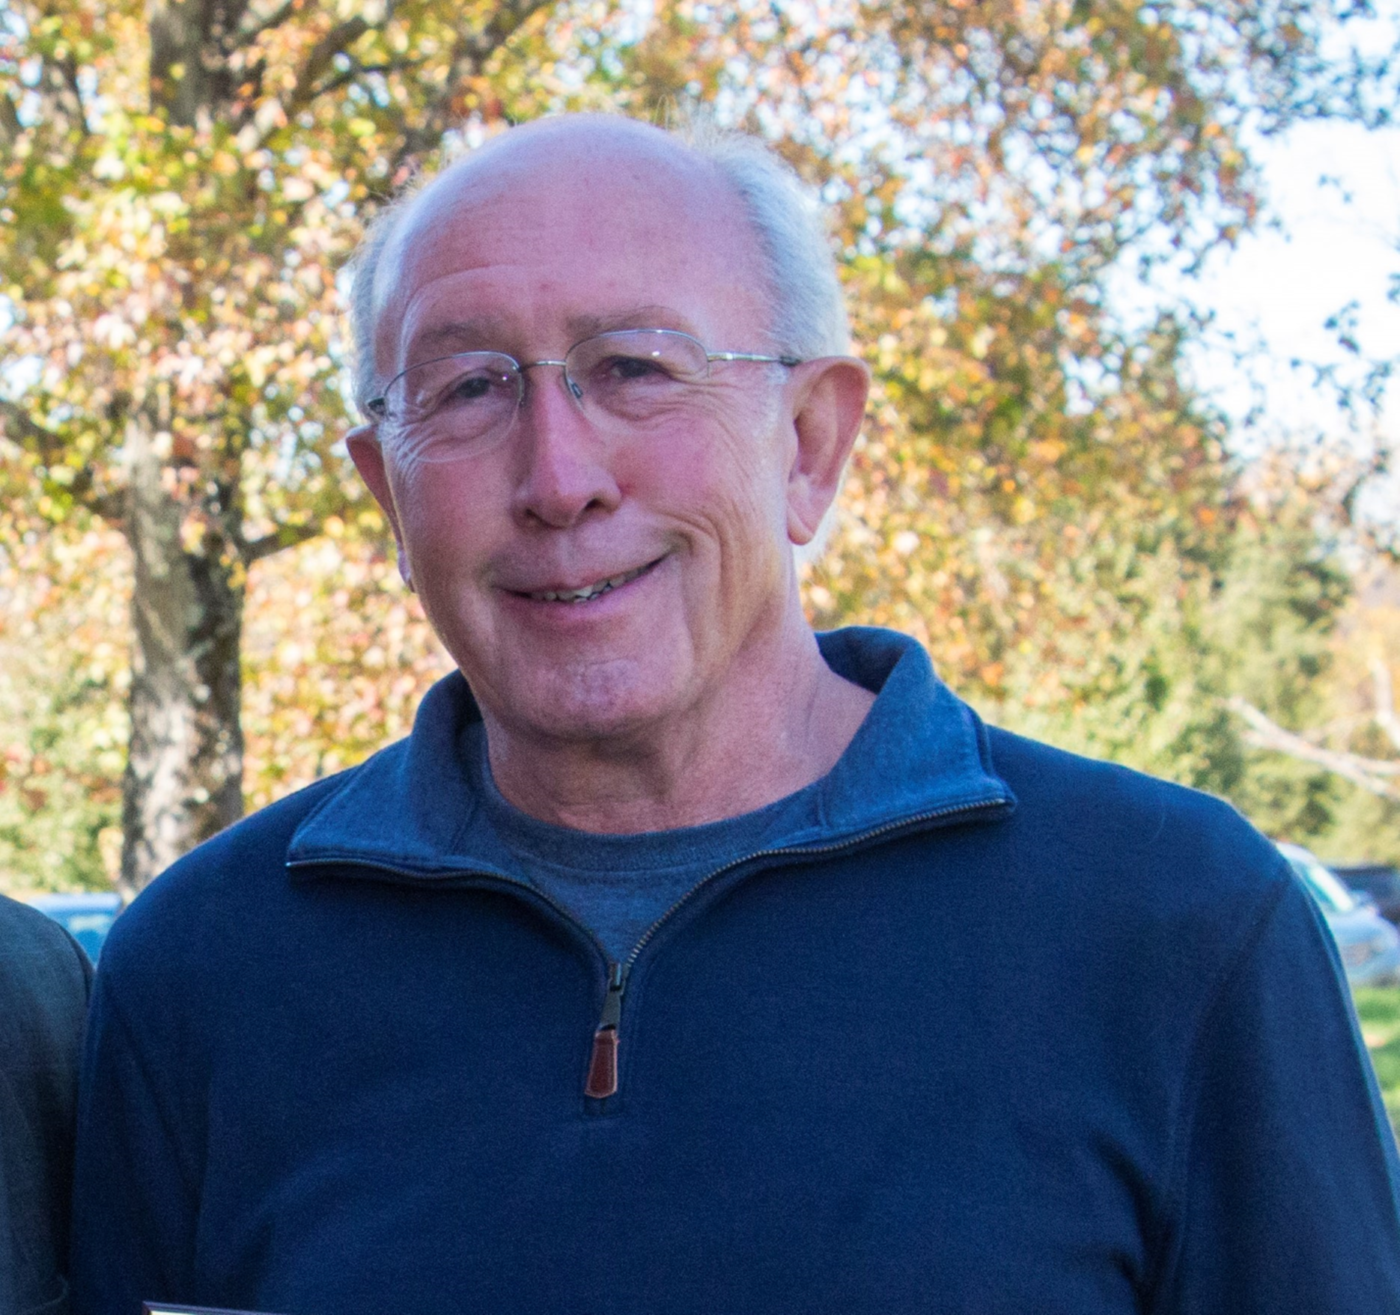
[71, 963, 197, 1315]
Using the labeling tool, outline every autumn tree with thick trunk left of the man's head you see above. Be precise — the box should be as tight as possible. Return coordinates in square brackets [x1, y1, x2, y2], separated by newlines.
[0, 0, 590, 893]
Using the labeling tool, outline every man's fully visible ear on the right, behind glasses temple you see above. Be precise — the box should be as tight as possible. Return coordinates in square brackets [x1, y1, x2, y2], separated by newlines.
[787, 356, 871, 545]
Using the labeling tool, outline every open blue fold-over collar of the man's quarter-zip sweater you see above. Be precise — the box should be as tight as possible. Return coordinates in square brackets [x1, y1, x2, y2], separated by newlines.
[287, 626, 1015, 877]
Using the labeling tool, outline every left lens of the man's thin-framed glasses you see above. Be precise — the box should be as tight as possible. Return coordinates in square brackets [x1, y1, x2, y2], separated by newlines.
[385, 352, 521, 462]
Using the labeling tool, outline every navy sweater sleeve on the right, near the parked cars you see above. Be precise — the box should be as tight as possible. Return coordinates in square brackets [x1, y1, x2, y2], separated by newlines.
[1152, 881, 1400, 1315]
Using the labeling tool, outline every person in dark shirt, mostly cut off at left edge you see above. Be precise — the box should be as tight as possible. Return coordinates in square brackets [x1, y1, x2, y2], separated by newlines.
[0, 895, 92, 1315]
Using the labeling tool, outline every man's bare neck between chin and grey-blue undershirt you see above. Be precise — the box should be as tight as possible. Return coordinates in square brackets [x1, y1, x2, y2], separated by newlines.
[482, 609, 875, 833]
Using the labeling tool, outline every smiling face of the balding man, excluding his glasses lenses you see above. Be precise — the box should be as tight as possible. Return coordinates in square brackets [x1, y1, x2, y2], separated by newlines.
[356, 133, 812, 756]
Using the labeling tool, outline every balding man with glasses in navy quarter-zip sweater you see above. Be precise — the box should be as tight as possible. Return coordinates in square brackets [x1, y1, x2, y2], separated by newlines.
[76, 118, 1400, 1315]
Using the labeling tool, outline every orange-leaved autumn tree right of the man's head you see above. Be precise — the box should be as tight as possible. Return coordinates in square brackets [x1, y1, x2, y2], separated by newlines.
[623, 0, 1393, 722]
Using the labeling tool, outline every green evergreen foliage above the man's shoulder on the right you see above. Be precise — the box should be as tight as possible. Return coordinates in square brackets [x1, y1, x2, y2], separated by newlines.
[980, 484, 1348, 806]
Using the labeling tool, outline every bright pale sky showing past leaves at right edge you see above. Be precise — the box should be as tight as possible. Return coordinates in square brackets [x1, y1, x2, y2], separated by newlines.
[1114, 0, 1400, 537]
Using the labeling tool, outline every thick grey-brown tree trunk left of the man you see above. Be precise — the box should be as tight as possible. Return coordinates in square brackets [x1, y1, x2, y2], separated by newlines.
[119, 423, 244, 899]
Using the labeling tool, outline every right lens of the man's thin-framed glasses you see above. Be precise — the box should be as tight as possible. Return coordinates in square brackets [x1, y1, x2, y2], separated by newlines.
[564, 329, 710, 420]
